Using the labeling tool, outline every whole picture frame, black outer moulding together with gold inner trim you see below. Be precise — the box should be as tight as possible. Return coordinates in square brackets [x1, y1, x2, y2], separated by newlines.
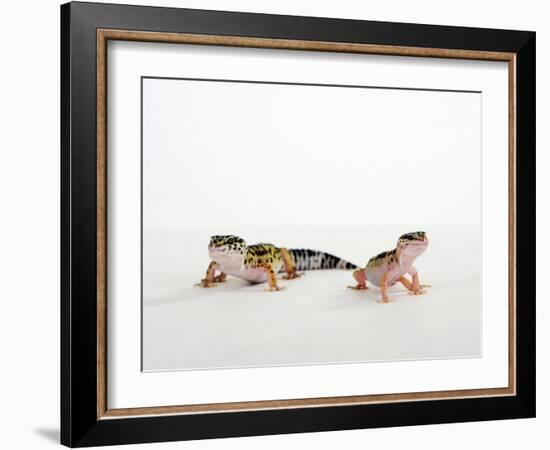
[61, 2, 536, 447]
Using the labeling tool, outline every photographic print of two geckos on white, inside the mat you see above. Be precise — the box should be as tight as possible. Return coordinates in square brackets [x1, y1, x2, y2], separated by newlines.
[141, 76, 482, 372]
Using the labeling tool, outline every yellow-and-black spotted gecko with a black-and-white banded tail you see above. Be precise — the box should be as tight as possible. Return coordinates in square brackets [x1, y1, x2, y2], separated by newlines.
[197, 235, 357, 291]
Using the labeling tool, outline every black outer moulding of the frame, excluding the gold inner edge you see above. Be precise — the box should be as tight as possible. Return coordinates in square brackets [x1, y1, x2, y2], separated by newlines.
[60, 2, 536, 447]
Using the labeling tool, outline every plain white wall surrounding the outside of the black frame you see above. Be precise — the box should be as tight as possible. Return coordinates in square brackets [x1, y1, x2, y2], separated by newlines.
[0, 0, 550, 450]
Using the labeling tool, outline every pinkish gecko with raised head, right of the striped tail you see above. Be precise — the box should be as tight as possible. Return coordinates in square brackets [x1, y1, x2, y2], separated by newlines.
[348, 231, 430, 303]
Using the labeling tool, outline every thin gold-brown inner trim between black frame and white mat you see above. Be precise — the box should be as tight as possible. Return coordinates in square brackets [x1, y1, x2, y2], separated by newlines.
[97, 29, 516, 420]
